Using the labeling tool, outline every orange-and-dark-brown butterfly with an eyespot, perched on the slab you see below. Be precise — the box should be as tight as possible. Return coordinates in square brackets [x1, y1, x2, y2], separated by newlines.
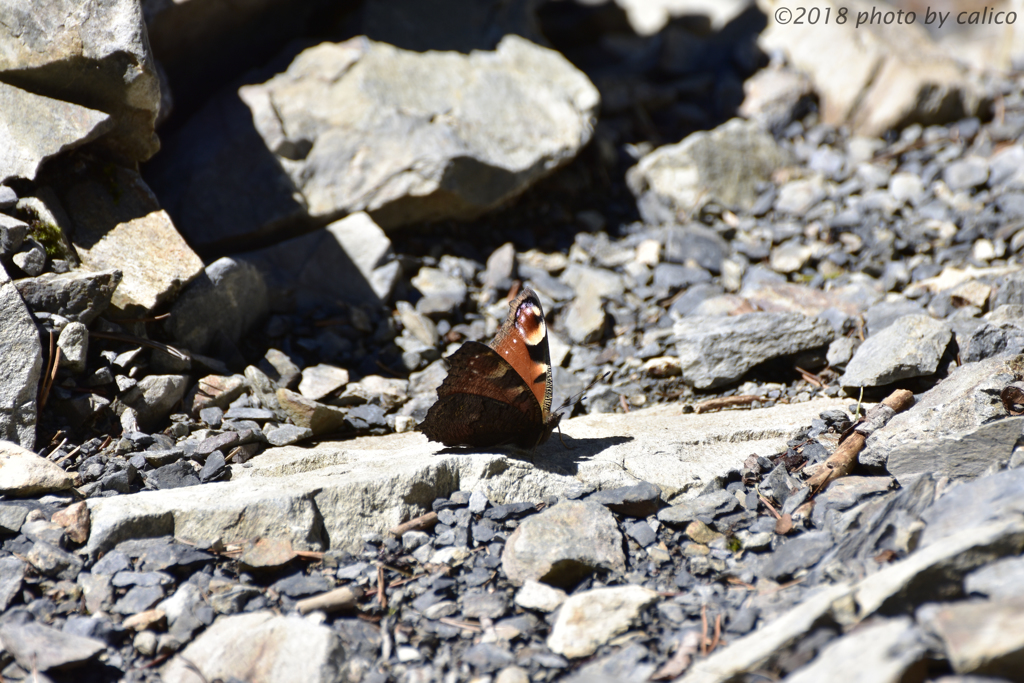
[419, 288, 562, 449]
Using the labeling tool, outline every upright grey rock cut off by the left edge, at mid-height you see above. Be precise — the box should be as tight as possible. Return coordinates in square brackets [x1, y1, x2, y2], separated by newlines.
[0, 281, 43, 449]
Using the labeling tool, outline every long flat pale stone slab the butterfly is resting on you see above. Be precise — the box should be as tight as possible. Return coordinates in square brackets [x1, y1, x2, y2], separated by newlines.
[87, 400, 844, 555]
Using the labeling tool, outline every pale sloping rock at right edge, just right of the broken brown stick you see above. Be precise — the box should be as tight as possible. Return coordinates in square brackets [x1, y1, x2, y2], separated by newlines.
[858, 356, 1019, 467]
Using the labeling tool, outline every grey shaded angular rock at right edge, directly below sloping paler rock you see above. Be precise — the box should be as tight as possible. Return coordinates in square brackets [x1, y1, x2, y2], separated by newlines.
[886, 417, 1024, 480]
